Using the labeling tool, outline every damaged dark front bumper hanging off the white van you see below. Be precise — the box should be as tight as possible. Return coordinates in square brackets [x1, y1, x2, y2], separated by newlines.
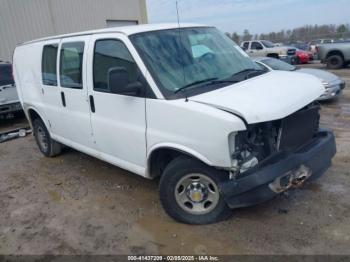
[219, 130, 336, 208]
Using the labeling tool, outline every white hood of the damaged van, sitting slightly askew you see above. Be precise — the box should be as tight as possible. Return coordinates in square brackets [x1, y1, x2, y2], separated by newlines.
[189, 71, 325, 124]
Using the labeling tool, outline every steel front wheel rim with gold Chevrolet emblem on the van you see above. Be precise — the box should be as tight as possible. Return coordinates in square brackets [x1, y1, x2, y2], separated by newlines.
[175, 173, 220, 215]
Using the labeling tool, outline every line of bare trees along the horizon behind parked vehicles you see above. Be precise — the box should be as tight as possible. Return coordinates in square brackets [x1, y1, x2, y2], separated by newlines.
[226, 24, 350, 43]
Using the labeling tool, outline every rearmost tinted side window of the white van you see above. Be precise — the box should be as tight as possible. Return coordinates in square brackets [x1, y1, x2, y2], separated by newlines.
[41, 44, 58, 86]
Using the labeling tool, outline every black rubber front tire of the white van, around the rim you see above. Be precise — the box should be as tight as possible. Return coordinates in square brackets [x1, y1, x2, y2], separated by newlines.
[159, 156, 231, 225]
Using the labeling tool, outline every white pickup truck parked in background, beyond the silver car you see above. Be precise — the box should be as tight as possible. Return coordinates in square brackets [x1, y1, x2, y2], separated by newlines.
[241, 40, 296, 58]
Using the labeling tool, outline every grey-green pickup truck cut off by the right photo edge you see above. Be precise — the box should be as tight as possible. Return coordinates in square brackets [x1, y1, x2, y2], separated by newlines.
[317, 42, 350, 69]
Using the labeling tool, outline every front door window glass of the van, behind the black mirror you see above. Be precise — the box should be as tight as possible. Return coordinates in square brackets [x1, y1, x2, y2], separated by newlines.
[93, 39, 140, 93]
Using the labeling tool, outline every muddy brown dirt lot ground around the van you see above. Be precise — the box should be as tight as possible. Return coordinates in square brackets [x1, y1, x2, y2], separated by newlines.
[0, 62, 350, 254]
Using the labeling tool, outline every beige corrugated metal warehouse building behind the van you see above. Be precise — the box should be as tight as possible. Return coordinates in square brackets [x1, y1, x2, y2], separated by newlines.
[0, 0, 147, 61]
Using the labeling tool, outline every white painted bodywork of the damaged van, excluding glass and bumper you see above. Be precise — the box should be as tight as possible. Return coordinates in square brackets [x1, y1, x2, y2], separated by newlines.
[14, 24, 324, 177]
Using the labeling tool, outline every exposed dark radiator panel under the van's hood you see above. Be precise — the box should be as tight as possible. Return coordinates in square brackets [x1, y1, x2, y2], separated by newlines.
[277, 105, 320, 151]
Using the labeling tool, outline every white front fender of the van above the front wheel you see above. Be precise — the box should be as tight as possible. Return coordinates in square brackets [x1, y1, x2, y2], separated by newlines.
[147, 99, 246, 170]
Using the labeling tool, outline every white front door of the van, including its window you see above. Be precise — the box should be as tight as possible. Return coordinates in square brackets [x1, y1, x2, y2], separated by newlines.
[88, 33, 146, 175]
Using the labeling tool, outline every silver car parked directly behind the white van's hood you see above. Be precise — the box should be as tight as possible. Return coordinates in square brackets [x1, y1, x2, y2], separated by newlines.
[254, 57, 345, 101]
